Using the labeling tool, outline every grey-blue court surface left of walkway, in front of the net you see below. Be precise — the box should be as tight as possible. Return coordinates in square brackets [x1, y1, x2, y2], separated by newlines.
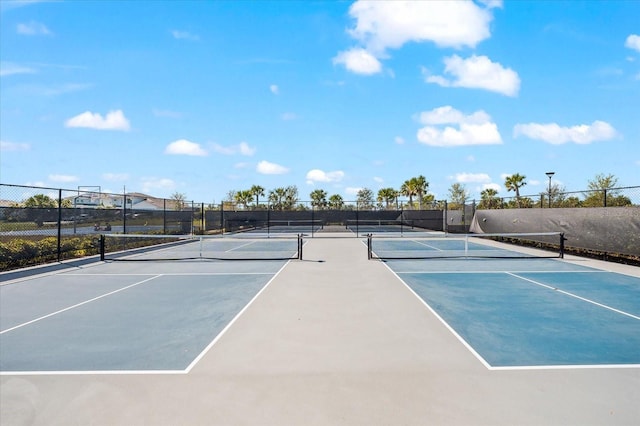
[0, 262, 284, 372]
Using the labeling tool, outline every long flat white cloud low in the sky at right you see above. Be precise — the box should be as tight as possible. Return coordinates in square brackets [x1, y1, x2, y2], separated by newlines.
[513, 121, 617, 145]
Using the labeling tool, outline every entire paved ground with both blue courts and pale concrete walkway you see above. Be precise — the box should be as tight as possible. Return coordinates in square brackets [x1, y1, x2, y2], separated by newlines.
[0, 232, 640, 425]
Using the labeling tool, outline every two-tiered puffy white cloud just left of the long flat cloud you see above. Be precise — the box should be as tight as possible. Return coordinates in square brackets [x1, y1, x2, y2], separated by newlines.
[417, 106, 502, 147]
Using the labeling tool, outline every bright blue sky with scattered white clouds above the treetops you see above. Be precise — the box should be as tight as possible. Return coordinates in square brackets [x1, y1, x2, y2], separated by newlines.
[0, 0, 640, 202]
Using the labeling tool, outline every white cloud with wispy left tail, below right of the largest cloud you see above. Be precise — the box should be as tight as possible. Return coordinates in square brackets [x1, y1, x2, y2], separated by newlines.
[423, 55, 520, 96]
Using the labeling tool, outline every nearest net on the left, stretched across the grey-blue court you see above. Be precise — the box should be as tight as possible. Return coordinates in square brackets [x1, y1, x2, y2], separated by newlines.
[100, 234, 303, 261]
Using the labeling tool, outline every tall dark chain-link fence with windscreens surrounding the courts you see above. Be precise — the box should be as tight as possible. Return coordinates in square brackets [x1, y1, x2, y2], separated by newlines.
[0, 184, 640, 271]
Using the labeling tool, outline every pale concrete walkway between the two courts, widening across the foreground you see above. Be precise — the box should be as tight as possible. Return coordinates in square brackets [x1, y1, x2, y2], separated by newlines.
[0, 238, 640, 426]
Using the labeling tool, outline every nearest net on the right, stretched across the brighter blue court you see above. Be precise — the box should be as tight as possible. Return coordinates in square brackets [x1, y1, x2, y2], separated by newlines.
[367, 232, 565, 260]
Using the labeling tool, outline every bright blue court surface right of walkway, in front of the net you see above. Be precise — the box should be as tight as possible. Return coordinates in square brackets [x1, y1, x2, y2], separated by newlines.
[387, 259, 640, 368]
